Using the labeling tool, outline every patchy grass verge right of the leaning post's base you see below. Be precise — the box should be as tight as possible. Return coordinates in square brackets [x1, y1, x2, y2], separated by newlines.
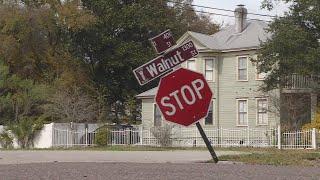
[219, 149, 320, 166]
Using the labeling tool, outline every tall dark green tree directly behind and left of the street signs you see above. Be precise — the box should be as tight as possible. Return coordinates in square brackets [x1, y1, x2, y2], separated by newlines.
[73, 0, 220, 122]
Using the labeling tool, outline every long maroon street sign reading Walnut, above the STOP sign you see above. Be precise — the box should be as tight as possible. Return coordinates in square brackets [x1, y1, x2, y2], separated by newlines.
[133, 41, 198, 85]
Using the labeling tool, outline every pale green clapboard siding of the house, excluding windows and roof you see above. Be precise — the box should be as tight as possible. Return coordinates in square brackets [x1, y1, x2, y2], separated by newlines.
[142, 48, 279, 128]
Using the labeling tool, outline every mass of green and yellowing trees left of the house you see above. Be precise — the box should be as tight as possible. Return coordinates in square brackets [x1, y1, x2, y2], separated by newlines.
[0, 0, 219, 124]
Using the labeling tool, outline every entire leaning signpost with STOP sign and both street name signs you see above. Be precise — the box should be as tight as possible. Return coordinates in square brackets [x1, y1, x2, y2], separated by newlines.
[133, 30, 218, 163]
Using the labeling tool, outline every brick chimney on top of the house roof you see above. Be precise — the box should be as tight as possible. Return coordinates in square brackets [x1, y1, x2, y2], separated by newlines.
[234, 4, 248, 33]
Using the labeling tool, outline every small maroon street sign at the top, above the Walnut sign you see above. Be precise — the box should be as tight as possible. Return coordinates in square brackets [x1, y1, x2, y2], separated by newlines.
[149, 29, 176, 54]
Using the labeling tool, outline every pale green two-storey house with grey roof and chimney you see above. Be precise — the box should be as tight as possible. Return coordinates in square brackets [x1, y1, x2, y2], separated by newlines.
[137, 5, 317, 129]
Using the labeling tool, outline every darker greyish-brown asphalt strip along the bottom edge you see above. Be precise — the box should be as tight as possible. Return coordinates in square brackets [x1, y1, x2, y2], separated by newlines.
[0, 162, 320, 180]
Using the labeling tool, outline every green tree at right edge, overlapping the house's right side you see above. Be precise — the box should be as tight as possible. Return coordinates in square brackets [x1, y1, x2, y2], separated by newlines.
[257, 0, 320, 91]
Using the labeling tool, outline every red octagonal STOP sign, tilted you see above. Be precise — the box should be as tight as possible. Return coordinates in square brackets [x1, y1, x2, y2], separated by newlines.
[156, 68, 212, 126]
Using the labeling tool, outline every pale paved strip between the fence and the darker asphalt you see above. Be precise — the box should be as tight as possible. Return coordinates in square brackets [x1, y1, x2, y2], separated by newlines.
[0, 150, 245, 164]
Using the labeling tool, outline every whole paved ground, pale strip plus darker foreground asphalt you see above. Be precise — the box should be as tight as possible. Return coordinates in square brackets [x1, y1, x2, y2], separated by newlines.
[0, 151, 320, 180]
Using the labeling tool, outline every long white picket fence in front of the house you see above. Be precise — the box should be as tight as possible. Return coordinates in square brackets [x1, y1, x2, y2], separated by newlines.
[52, 127, 320, 149]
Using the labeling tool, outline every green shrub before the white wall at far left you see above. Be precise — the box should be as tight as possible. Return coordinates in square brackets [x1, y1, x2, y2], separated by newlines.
[7, 117, 43, 149]
